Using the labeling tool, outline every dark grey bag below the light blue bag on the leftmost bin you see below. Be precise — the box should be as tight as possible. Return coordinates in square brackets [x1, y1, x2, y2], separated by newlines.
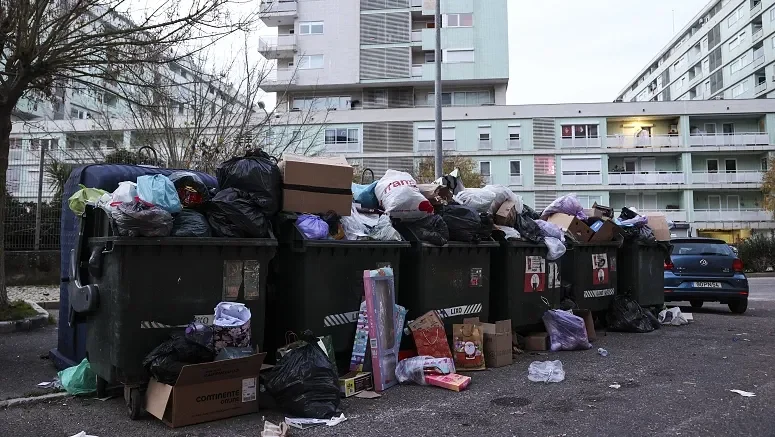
[111, 201, 173, 237]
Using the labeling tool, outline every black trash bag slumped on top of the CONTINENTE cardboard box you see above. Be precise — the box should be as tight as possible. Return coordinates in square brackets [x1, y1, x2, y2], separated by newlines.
[143, 335, 215, 385]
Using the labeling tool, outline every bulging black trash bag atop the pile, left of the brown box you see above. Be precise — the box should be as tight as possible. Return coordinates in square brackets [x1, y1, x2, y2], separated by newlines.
[215, 150, 283, 216]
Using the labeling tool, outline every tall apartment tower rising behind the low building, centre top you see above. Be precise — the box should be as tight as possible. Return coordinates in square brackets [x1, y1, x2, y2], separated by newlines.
[259, 0, 509, 110]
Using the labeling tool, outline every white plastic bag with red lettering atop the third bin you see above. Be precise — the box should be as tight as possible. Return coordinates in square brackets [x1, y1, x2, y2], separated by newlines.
[374, 170, 433, 221]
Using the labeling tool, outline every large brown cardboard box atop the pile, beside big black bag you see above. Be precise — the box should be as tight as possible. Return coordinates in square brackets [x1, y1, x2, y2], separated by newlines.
[278, 154, 353, 216]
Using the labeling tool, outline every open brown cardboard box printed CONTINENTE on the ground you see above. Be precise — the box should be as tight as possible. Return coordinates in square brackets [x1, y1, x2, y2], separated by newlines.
[145, 353, 266, 428]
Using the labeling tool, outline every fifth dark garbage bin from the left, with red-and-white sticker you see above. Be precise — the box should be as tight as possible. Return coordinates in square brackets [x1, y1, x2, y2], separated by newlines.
[561, 241, 621, 312]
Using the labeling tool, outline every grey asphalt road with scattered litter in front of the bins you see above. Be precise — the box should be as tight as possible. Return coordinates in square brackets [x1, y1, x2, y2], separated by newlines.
[0, 278, 775, 437]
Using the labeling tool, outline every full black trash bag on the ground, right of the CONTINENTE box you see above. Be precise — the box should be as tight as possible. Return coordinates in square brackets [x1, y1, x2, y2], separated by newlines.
[266, 341, 339, 419]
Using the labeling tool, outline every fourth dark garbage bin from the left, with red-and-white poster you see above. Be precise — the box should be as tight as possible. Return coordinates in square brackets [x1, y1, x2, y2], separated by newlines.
[490, 240, 562, 331]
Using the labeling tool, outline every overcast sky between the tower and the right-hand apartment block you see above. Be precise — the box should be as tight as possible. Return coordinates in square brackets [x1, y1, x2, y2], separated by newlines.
[507, 0, 709, 105]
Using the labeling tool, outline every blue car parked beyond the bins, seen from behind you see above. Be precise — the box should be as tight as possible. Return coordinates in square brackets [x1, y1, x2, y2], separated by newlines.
[665, 238, 748, 314]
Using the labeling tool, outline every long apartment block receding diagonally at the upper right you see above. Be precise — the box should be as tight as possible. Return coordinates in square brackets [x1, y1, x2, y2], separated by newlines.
[616, 0, 775, 102]
